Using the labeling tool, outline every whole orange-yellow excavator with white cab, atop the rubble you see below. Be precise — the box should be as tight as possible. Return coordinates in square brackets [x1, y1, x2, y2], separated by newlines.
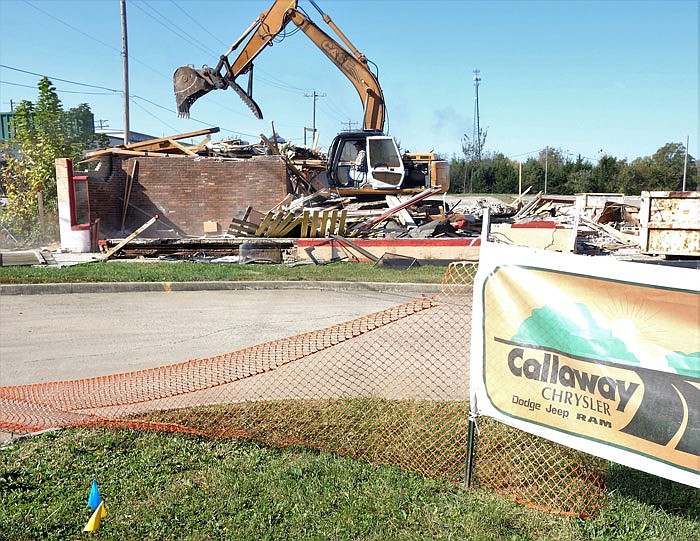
[173, 0, 449, 195]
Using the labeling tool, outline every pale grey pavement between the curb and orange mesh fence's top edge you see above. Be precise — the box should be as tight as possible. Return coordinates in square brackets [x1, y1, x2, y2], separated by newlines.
[0, 285, 432, 385]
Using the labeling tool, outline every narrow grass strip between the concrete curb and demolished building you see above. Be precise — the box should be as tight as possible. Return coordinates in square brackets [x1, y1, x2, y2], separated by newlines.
[0, 261, 446, 284]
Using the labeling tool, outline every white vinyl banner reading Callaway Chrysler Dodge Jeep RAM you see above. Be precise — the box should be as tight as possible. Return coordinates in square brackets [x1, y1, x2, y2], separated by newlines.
[470, 242, 700, 488]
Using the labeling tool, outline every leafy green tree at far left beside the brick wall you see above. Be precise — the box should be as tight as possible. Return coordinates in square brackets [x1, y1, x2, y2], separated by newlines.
[0, 77, 94, 242]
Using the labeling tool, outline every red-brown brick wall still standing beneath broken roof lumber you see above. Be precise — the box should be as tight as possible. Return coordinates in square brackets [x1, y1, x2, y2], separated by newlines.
[89, 156, 289, 237]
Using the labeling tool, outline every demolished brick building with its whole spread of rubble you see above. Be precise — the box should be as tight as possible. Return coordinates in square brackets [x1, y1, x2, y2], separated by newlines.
[50, 128, 700, 263]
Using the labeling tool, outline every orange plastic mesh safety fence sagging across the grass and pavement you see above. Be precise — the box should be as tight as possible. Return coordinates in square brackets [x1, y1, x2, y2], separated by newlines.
[0, 263, 603, 516]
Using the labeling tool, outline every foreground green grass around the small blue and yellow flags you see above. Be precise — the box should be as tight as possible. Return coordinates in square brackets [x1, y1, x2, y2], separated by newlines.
[0, 429, 700, 541]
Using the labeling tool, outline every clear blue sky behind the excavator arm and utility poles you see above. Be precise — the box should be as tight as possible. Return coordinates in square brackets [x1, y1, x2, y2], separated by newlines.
[0, 0, 698, 162]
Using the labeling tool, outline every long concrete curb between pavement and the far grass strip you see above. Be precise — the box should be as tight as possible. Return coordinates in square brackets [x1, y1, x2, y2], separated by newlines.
[0, 281, 440, 295]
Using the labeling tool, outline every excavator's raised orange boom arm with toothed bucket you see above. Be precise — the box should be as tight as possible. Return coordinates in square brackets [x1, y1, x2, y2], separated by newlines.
[173, 0, 385, 131]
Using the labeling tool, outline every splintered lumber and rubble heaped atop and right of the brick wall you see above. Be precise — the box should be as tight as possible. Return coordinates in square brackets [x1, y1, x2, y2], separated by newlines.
[84, 128, 700, 257]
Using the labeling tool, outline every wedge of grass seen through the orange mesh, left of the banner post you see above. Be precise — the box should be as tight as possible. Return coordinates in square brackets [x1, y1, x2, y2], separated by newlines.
[135, 398, 469, 480]
